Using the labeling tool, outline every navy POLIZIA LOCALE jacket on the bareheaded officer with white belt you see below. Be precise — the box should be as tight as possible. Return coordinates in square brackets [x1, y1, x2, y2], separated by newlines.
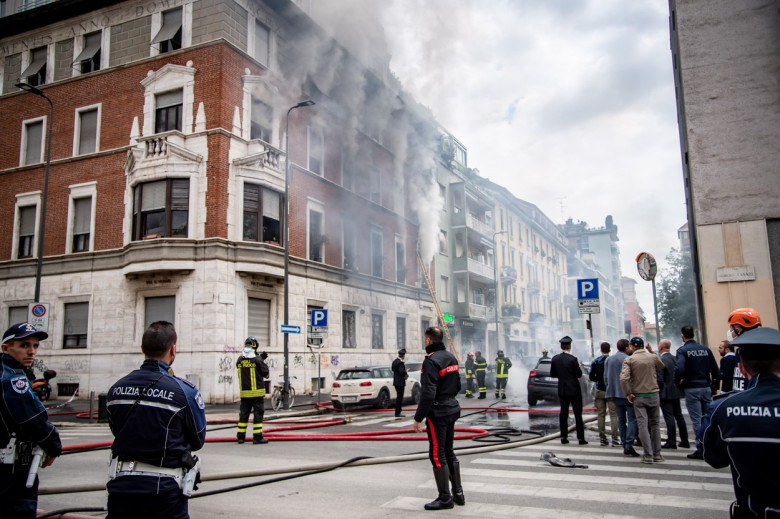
[106, 359, 206, 490]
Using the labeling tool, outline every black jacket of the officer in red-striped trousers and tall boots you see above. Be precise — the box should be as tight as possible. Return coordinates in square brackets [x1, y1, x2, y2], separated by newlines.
[414, 342, 460, 422]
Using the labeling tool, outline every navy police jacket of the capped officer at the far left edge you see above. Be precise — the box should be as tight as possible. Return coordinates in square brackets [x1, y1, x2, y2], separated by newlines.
[0, 353, 62, 457]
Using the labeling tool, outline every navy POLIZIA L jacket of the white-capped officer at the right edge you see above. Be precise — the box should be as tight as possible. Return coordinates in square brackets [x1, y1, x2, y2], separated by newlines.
[704, 373, 780, 517]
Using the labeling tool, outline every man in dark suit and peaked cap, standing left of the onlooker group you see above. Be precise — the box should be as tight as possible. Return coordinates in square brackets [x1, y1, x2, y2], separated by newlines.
[550, 335, 588, 445]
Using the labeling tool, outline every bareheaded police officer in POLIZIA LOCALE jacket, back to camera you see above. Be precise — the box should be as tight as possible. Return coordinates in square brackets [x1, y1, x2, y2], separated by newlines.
[106, 321, 206, 519]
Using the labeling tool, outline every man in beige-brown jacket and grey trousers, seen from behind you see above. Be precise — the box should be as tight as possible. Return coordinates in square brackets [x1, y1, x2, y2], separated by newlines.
[620, 337, 664, 463]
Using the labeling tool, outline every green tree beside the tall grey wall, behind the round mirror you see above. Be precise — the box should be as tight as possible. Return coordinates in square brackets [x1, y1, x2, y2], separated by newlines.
[657, 248, 696, 339]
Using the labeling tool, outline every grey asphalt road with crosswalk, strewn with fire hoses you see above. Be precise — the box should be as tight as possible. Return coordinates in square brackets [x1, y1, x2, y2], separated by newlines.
[39, 395, 733, 519]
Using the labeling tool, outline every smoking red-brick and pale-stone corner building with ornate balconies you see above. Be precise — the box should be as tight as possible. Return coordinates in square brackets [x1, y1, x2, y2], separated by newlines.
[0, 0, 441, 403]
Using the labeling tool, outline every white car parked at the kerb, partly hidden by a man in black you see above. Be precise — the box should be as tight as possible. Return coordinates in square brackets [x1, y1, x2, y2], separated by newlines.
[330, 366, 420, 409]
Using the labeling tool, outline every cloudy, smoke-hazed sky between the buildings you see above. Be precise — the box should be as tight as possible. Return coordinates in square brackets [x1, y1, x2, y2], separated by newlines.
[315, 0, 686, 322]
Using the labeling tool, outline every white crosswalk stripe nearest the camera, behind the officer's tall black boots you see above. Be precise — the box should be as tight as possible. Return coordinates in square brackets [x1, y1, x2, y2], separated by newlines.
[382, 496, 652, 519]
